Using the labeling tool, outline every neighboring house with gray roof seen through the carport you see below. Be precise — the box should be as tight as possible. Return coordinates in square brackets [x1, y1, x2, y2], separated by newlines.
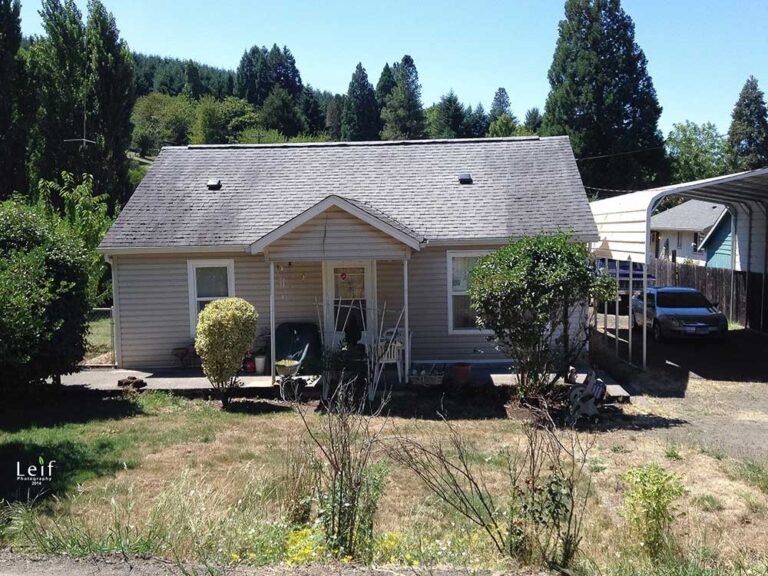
[651, 200, 730, 267]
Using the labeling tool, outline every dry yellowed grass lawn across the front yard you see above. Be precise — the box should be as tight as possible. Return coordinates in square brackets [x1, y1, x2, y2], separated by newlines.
[0, 379, 768, 570]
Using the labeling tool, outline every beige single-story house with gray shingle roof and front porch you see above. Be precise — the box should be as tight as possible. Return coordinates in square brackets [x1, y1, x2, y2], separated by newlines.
[100, 137, 597, 369]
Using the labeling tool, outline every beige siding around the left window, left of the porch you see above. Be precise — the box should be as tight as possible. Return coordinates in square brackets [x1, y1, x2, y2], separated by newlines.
[112, 254, 269, 369]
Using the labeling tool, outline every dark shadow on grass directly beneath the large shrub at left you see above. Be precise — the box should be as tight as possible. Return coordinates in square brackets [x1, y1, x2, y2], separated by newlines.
[0, 384, 144, 432]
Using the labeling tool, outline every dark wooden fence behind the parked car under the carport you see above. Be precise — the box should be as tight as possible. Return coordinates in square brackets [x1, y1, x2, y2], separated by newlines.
[648, 258, 768, 332]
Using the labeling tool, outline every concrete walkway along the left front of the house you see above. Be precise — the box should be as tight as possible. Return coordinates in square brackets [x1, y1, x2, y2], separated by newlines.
[61, 368, 311, 390]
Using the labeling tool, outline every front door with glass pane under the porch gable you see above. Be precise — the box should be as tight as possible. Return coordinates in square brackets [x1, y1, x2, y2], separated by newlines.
[323, 260, 376, 347]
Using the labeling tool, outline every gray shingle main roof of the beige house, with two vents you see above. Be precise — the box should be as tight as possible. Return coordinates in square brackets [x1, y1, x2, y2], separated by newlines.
[101, 137, 597, 251]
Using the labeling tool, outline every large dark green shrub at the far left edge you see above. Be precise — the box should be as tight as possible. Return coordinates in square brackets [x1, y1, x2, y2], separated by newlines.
[0, 200, 90, 386]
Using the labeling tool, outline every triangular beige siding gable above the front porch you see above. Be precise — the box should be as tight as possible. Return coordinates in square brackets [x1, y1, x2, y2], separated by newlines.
[267, 206, 407, 261]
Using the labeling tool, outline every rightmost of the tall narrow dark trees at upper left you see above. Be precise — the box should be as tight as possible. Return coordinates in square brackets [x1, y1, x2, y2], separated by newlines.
[85, 0, 136, 206]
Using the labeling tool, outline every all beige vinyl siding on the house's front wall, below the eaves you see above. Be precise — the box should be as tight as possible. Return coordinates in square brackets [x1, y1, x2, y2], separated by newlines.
[113, 246, 516, 370]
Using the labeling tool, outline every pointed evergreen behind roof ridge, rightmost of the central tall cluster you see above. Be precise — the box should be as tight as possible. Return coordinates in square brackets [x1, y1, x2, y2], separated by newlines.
[381, 54, 425, 140]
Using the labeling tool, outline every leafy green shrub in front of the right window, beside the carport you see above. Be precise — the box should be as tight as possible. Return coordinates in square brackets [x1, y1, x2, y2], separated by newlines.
[469, 232, 611, 397]
